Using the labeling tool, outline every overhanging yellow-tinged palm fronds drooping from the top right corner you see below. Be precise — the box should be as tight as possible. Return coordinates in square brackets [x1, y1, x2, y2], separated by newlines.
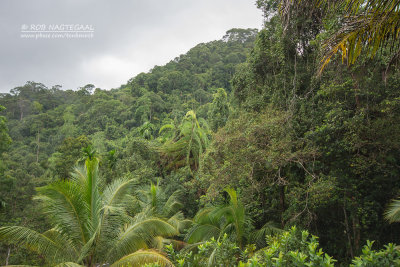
[280, 0, 400, 71]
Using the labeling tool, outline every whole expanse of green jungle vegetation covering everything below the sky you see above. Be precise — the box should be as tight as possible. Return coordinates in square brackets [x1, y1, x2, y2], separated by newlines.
[0, 0, 400, 266]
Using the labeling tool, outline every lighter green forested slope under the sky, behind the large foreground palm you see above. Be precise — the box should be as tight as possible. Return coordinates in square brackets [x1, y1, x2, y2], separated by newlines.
[0, 29, 257, 265]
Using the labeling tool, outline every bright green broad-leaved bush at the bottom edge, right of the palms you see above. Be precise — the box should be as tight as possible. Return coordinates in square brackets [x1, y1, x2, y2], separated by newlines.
[166, 227, 336, 267]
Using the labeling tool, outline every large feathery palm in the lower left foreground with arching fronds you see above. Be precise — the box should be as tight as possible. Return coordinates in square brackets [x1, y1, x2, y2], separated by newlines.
[0, 154, 178, 266]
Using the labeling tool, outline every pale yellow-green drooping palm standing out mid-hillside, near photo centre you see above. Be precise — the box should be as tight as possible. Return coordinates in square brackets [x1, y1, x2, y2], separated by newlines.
[160, 110, 210, 174]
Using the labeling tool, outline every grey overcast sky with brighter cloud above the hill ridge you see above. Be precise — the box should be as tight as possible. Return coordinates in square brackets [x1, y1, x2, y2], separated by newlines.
[0, 0, 262, 92]
